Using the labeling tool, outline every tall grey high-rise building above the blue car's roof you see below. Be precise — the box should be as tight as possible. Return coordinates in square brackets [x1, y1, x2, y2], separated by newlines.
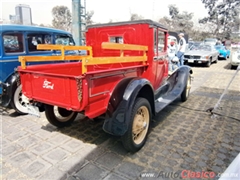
[15, 4, 32, 25]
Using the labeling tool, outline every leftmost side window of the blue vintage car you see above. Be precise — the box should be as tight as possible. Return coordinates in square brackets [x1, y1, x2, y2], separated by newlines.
[3, 33, 24, 54]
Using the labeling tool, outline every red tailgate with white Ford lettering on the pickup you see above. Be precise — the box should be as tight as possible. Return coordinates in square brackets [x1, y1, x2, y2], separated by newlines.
[20, 72, 82, 110]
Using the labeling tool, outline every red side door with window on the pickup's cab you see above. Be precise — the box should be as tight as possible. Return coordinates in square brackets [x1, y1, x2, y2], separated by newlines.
[154, 28, 168, 89]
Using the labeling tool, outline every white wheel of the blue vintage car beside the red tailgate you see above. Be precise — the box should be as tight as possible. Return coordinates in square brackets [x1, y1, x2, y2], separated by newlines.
[10, 83, 30, 115]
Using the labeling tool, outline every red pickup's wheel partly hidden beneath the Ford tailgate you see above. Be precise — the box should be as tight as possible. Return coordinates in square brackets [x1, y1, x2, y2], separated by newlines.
[45, 105, 78, 128]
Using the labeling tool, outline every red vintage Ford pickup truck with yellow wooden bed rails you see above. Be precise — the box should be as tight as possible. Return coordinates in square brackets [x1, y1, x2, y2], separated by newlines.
[18, 20, 192, 152]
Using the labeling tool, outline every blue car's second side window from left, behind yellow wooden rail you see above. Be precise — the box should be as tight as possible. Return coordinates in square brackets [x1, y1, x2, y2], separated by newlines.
[27, 34, 51, 52]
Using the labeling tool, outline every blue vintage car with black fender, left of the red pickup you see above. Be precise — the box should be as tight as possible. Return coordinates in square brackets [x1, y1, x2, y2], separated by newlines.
[0, 25, 76, 114]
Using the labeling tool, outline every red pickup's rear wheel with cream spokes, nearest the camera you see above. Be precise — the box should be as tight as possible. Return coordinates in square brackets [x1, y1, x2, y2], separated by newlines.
[121, 98, 152, 152]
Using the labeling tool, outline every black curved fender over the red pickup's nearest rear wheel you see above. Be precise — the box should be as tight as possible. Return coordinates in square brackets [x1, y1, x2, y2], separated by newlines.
[103, 78, 153, 136]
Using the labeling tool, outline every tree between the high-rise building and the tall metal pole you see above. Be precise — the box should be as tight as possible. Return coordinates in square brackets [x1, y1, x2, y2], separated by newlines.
[52, 6, 72, 32]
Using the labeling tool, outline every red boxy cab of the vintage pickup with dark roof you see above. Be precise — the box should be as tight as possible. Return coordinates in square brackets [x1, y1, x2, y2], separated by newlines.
[86, 20, 168, 90]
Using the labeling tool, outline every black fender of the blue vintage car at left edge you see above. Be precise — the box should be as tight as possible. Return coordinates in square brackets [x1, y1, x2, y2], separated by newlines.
[1, 73, 20, 107]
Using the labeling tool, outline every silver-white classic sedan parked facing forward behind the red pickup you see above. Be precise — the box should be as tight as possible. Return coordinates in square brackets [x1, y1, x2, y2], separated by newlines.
[184, 44, 219, 67]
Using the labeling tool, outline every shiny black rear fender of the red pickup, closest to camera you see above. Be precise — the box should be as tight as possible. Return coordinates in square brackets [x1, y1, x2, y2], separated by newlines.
[103, 78, 155, 136]
